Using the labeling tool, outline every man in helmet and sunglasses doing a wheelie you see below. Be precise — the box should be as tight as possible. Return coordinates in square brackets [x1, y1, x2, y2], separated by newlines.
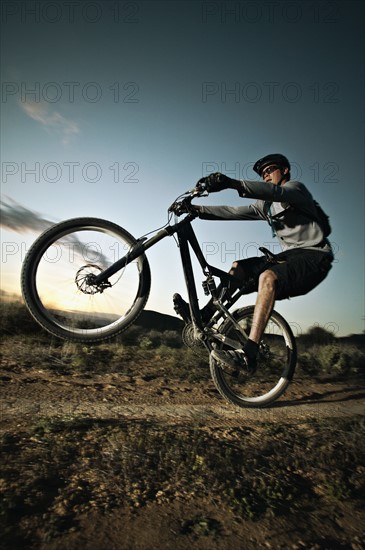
[174, 153, 333, 372]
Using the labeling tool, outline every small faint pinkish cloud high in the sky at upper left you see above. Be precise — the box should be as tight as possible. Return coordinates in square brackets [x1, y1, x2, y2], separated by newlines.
[20, 101, 80, 145]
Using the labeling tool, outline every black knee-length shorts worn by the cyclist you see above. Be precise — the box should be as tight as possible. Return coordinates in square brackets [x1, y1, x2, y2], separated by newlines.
[237, 248, 333, 300]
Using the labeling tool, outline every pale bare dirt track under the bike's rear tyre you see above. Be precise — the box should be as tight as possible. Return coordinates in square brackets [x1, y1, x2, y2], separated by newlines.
[1, 370, 365, 426]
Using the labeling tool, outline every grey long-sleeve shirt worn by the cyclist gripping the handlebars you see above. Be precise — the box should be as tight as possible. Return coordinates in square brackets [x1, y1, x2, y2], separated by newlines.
[199, 180, 332, 254]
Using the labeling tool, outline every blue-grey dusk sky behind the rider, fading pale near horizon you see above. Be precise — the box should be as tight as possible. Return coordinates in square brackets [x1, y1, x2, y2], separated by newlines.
[1, 0, 364, 335]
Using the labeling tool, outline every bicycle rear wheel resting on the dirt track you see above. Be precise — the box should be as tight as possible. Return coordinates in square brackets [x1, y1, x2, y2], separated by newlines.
[210, 306, 297, 407]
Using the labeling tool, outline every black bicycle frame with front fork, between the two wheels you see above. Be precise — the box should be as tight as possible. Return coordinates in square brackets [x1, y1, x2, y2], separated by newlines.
[92, 215, 247, 338]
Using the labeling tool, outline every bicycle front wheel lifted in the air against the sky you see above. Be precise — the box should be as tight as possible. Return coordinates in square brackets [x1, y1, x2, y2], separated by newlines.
[21, 218, 151, 342]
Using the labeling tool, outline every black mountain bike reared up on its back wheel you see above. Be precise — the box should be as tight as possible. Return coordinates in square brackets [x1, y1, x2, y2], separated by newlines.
[21, 184, 297, 407]
